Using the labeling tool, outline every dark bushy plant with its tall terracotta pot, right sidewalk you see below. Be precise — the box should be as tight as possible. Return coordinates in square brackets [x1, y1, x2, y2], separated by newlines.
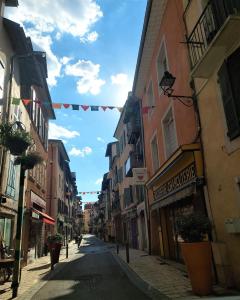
[176, 212, 212, 296]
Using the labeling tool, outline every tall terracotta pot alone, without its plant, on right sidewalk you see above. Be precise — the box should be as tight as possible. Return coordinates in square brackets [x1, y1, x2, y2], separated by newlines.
[181, 242, 212, 296]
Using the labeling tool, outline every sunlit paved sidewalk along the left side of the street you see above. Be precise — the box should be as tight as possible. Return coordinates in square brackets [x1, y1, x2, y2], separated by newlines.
[0, 241, 79, 300]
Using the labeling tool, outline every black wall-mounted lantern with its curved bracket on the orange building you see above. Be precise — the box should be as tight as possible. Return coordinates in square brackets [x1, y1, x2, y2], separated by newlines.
[159, 71, 194, 107]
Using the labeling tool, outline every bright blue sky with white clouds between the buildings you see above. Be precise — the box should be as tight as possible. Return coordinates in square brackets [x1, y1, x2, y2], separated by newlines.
[7, 0, 147, 201]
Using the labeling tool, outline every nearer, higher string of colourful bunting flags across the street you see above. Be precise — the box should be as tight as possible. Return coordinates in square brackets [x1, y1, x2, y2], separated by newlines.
[12, 97, 155, 114]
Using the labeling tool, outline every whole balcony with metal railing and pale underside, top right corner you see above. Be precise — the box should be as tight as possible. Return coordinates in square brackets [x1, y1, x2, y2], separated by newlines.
[187, 0, 240, 78]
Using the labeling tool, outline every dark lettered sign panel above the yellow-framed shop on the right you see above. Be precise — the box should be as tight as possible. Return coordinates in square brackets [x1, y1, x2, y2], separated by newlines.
[154, 164, 196, 200]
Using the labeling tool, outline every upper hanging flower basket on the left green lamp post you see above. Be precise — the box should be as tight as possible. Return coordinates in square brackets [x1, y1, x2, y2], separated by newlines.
[0, 123, 32, 155]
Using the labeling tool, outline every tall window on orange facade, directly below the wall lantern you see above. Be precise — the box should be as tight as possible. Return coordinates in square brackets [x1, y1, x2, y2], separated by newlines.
[163, 109, 177, 158]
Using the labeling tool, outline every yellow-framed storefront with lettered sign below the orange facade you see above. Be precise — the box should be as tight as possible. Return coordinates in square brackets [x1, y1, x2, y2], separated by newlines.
[146, 144, 205, 261]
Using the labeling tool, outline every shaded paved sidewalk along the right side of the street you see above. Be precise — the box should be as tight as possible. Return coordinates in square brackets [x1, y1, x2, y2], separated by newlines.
[111, 246, 240, 300]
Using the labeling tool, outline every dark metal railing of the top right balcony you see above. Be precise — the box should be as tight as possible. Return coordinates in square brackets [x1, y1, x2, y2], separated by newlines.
[187, 0, 240, 67]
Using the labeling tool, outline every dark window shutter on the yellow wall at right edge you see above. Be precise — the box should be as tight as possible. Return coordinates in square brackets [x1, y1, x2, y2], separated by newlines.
[218, 61, 240, 140]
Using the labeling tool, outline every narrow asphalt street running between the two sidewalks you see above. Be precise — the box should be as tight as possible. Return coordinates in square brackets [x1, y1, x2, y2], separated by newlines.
[32, 235, 150, 300]
